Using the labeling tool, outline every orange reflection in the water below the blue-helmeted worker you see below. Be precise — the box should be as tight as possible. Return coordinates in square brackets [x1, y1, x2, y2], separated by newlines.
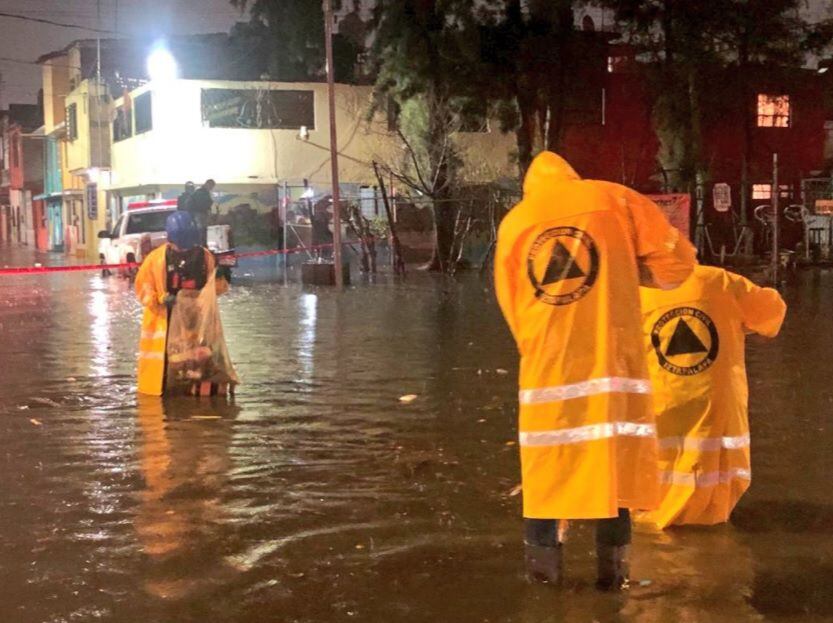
[134, 396, 239, 599]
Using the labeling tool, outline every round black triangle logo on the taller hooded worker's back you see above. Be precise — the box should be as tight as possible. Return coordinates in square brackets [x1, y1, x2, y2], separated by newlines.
[526, 227, 599, 305]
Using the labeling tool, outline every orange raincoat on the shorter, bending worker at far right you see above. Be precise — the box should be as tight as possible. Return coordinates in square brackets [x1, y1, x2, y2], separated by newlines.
[642, 266, 786, 528]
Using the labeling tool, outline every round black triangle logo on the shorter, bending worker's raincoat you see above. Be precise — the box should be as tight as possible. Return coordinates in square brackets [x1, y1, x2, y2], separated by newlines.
[651, 307, 720, 376]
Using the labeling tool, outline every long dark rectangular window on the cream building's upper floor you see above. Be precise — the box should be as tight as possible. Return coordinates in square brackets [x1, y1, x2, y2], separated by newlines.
[202, 89, 315, 130]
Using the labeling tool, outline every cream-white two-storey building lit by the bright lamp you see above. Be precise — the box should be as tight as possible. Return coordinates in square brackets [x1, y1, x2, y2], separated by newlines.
[108, 80, 516, 210]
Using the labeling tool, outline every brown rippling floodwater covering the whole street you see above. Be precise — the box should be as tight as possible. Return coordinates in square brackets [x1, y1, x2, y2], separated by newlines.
[0, 247, 833, 623]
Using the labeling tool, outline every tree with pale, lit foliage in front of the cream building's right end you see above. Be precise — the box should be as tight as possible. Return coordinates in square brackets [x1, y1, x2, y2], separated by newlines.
[372, 0, 472, 272]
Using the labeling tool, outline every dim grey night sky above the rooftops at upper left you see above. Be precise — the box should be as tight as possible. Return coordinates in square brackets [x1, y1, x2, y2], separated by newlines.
[0, 0, 247, 108]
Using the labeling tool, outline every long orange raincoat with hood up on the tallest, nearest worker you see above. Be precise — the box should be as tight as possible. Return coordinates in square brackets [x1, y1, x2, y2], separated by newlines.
[495, 152, 696, 519]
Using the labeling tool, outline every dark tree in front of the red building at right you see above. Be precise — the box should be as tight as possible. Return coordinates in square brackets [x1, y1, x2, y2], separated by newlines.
[604, 0, 833, 243]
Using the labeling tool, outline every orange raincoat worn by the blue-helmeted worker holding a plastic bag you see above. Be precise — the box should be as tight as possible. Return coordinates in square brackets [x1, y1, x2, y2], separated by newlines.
[136, 244, 228, 396]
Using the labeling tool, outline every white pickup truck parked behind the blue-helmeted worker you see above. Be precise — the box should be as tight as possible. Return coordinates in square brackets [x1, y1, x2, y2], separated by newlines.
[98, 199, 237, 276]
